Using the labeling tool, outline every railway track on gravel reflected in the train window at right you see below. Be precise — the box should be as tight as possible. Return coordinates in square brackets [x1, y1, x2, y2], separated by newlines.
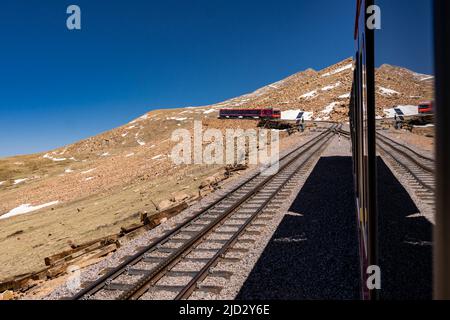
[338, 130, 435, 207]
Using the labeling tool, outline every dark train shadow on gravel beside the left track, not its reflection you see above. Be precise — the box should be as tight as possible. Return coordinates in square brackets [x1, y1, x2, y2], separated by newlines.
[237, 157, 359, 300]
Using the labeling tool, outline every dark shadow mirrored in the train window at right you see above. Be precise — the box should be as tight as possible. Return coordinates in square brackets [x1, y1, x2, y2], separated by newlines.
[378, 159, 433, 300]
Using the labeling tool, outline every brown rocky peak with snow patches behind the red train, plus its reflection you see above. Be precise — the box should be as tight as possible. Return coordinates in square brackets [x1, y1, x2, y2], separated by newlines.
[216, 58, 434, 121]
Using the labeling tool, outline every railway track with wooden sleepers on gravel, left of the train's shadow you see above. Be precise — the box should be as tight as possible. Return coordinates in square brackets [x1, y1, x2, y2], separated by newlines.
[71, 126, 336, 300]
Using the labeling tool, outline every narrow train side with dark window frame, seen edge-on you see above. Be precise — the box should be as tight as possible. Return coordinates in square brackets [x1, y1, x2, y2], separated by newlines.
[350, 0, 378, 300]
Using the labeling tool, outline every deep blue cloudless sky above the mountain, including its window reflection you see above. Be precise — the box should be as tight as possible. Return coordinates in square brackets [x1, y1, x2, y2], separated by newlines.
[0, 0, 432, 157]
